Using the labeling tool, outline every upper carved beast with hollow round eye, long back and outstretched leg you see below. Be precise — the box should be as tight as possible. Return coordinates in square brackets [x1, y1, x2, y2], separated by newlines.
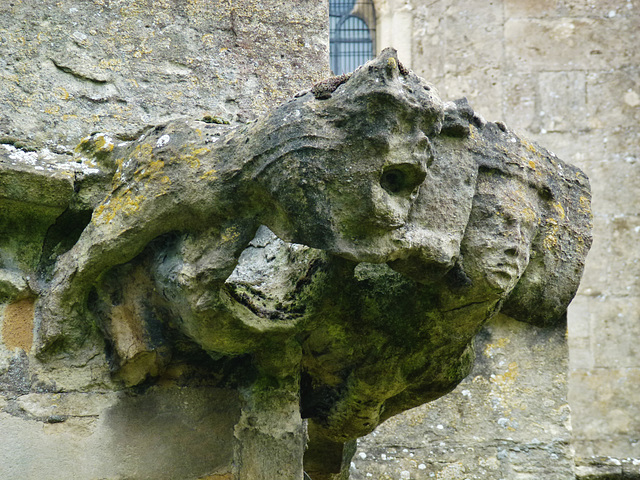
[41, 52, 444, 349]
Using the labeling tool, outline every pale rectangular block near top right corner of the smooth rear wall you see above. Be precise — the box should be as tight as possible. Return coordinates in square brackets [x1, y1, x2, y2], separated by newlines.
[504, 17, 640, 72]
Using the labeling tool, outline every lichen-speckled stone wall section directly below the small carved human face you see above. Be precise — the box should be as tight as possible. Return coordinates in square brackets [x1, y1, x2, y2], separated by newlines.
[350, 315, 574, 480]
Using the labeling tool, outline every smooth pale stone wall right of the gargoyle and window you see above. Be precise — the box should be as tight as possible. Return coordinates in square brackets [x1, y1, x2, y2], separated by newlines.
[356, 0, 640, 478]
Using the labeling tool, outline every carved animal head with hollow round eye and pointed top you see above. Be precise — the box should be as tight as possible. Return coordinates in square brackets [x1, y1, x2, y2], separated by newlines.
[249, 49, 444, 263]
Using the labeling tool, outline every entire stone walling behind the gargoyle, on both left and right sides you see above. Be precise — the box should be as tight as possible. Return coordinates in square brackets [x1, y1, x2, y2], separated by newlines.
[0, 0, 640, 479]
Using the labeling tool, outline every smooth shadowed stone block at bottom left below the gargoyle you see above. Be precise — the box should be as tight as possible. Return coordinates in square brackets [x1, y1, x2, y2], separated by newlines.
[0, 387, 240, 480]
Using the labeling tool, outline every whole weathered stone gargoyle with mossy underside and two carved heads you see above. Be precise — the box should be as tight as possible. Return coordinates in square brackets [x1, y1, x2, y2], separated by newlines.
[30, 49, 591, 480]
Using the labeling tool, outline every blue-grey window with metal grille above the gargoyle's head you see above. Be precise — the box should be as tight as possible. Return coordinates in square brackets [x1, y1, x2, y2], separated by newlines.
[329, 0, 376, 75]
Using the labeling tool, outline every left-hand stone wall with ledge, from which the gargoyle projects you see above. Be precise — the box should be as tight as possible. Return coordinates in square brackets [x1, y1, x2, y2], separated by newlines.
[0, 0, 328, 480]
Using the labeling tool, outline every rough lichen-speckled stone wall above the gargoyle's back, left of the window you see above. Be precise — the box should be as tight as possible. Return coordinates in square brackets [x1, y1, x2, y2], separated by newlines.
[0, 0, 328, 152]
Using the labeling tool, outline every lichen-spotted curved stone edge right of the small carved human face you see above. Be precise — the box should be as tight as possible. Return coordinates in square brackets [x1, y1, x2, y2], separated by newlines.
[502, 154, 592, 326]
